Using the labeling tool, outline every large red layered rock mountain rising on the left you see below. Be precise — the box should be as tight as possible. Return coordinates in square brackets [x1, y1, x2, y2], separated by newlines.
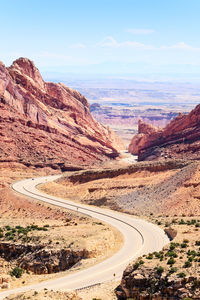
[0, 58, 122, 169]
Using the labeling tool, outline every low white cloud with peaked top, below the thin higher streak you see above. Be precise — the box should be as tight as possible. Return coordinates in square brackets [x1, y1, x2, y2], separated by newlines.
[96, 36, 153, 50]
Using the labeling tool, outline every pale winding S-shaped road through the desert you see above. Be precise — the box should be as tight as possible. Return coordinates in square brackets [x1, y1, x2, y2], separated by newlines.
[0, 175, 169, 299]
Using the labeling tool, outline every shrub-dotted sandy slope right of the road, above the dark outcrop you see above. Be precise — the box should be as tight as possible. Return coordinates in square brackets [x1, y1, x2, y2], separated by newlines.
[126, 216, 200, 295]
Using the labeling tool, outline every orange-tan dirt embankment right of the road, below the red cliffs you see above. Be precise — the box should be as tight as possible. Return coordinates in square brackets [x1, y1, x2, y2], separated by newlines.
[41, 160, 200, 216]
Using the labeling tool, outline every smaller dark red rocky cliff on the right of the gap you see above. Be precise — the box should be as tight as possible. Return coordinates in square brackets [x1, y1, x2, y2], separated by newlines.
[129, 104, 200, 160]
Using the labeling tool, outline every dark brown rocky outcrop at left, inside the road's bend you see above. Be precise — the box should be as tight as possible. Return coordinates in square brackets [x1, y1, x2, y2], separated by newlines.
[0, 242, 90, 274]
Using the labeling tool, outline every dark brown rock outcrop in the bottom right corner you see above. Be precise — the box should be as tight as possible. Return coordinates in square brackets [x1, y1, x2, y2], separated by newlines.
[116, 265, 200, 300]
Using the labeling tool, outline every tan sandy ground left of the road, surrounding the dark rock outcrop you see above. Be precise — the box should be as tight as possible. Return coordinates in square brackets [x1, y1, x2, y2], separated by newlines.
[0, 165, 123, 288]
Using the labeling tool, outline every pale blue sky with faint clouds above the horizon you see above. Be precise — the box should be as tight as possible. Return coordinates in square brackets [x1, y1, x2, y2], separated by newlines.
[0, 0, 200, 77]
